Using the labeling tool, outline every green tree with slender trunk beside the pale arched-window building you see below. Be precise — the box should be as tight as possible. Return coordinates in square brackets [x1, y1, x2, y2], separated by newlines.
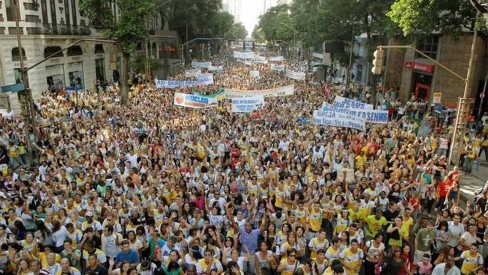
[79, 0, 154, 104]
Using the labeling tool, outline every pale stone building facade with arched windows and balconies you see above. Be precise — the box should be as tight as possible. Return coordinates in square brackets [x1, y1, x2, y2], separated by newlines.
[0, 0, 116, 103]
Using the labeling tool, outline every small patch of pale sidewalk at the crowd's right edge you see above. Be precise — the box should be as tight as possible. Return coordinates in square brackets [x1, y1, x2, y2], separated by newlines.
[460, 160, 488, 202]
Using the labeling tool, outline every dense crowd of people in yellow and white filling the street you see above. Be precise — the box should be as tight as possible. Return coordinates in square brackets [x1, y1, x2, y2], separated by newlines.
[0, 49, 488, 275]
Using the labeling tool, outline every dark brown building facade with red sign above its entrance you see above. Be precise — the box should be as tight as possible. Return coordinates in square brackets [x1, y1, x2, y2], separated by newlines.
[383, 33, 488, 109]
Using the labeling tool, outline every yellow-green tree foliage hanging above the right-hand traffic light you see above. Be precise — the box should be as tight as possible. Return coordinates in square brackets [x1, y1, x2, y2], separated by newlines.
[387, 0, 476, 37]
